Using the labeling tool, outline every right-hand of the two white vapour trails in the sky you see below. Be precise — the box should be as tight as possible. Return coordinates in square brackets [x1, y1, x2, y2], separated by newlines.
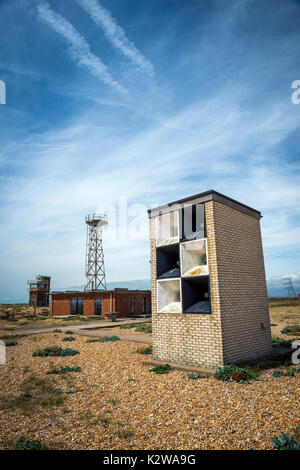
[76, 0, 154, 77]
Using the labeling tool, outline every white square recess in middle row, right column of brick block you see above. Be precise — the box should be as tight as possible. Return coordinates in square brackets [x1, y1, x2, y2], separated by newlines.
[180, 239, 209, 277]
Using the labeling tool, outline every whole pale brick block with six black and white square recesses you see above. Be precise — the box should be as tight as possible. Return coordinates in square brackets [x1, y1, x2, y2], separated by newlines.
[148, 191, 271, 368]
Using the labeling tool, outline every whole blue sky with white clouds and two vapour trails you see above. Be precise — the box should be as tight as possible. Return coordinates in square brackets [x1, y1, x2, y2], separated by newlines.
[0, 0, 300, 302]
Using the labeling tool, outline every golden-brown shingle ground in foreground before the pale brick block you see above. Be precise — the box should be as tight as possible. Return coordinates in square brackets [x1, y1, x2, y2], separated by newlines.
[0, 334, 300, 449]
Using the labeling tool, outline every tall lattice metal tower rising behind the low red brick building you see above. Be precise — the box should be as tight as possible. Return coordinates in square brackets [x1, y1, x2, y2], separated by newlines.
[84, 214, 108, 290]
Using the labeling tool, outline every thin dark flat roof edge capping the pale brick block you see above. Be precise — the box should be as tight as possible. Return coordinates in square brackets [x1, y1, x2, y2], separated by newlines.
[148, 189, 262, 219]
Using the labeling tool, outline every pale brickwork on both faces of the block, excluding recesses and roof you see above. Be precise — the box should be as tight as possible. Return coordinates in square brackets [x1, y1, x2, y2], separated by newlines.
[150, 201, 271, 368]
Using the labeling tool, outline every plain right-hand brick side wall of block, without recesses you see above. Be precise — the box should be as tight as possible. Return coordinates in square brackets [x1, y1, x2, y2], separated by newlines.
[210, 201, 271, 363]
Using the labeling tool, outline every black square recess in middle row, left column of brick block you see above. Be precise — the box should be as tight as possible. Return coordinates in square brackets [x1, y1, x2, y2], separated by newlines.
[156, 244, 180, 279]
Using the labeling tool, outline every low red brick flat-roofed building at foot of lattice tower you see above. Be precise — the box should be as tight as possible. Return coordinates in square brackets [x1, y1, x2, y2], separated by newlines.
[51, 289, 151, 316]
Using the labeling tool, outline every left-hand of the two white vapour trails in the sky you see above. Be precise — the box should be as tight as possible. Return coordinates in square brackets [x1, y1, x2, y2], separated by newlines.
[37, 1, 127, 95]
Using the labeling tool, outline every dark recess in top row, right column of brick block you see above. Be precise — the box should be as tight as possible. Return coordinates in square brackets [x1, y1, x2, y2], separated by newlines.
[180, 203, 206, 241]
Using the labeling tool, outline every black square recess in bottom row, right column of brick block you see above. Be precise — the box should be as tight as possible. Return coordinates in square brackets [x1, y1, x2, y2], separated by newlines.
[181, 276, 211, 313]
